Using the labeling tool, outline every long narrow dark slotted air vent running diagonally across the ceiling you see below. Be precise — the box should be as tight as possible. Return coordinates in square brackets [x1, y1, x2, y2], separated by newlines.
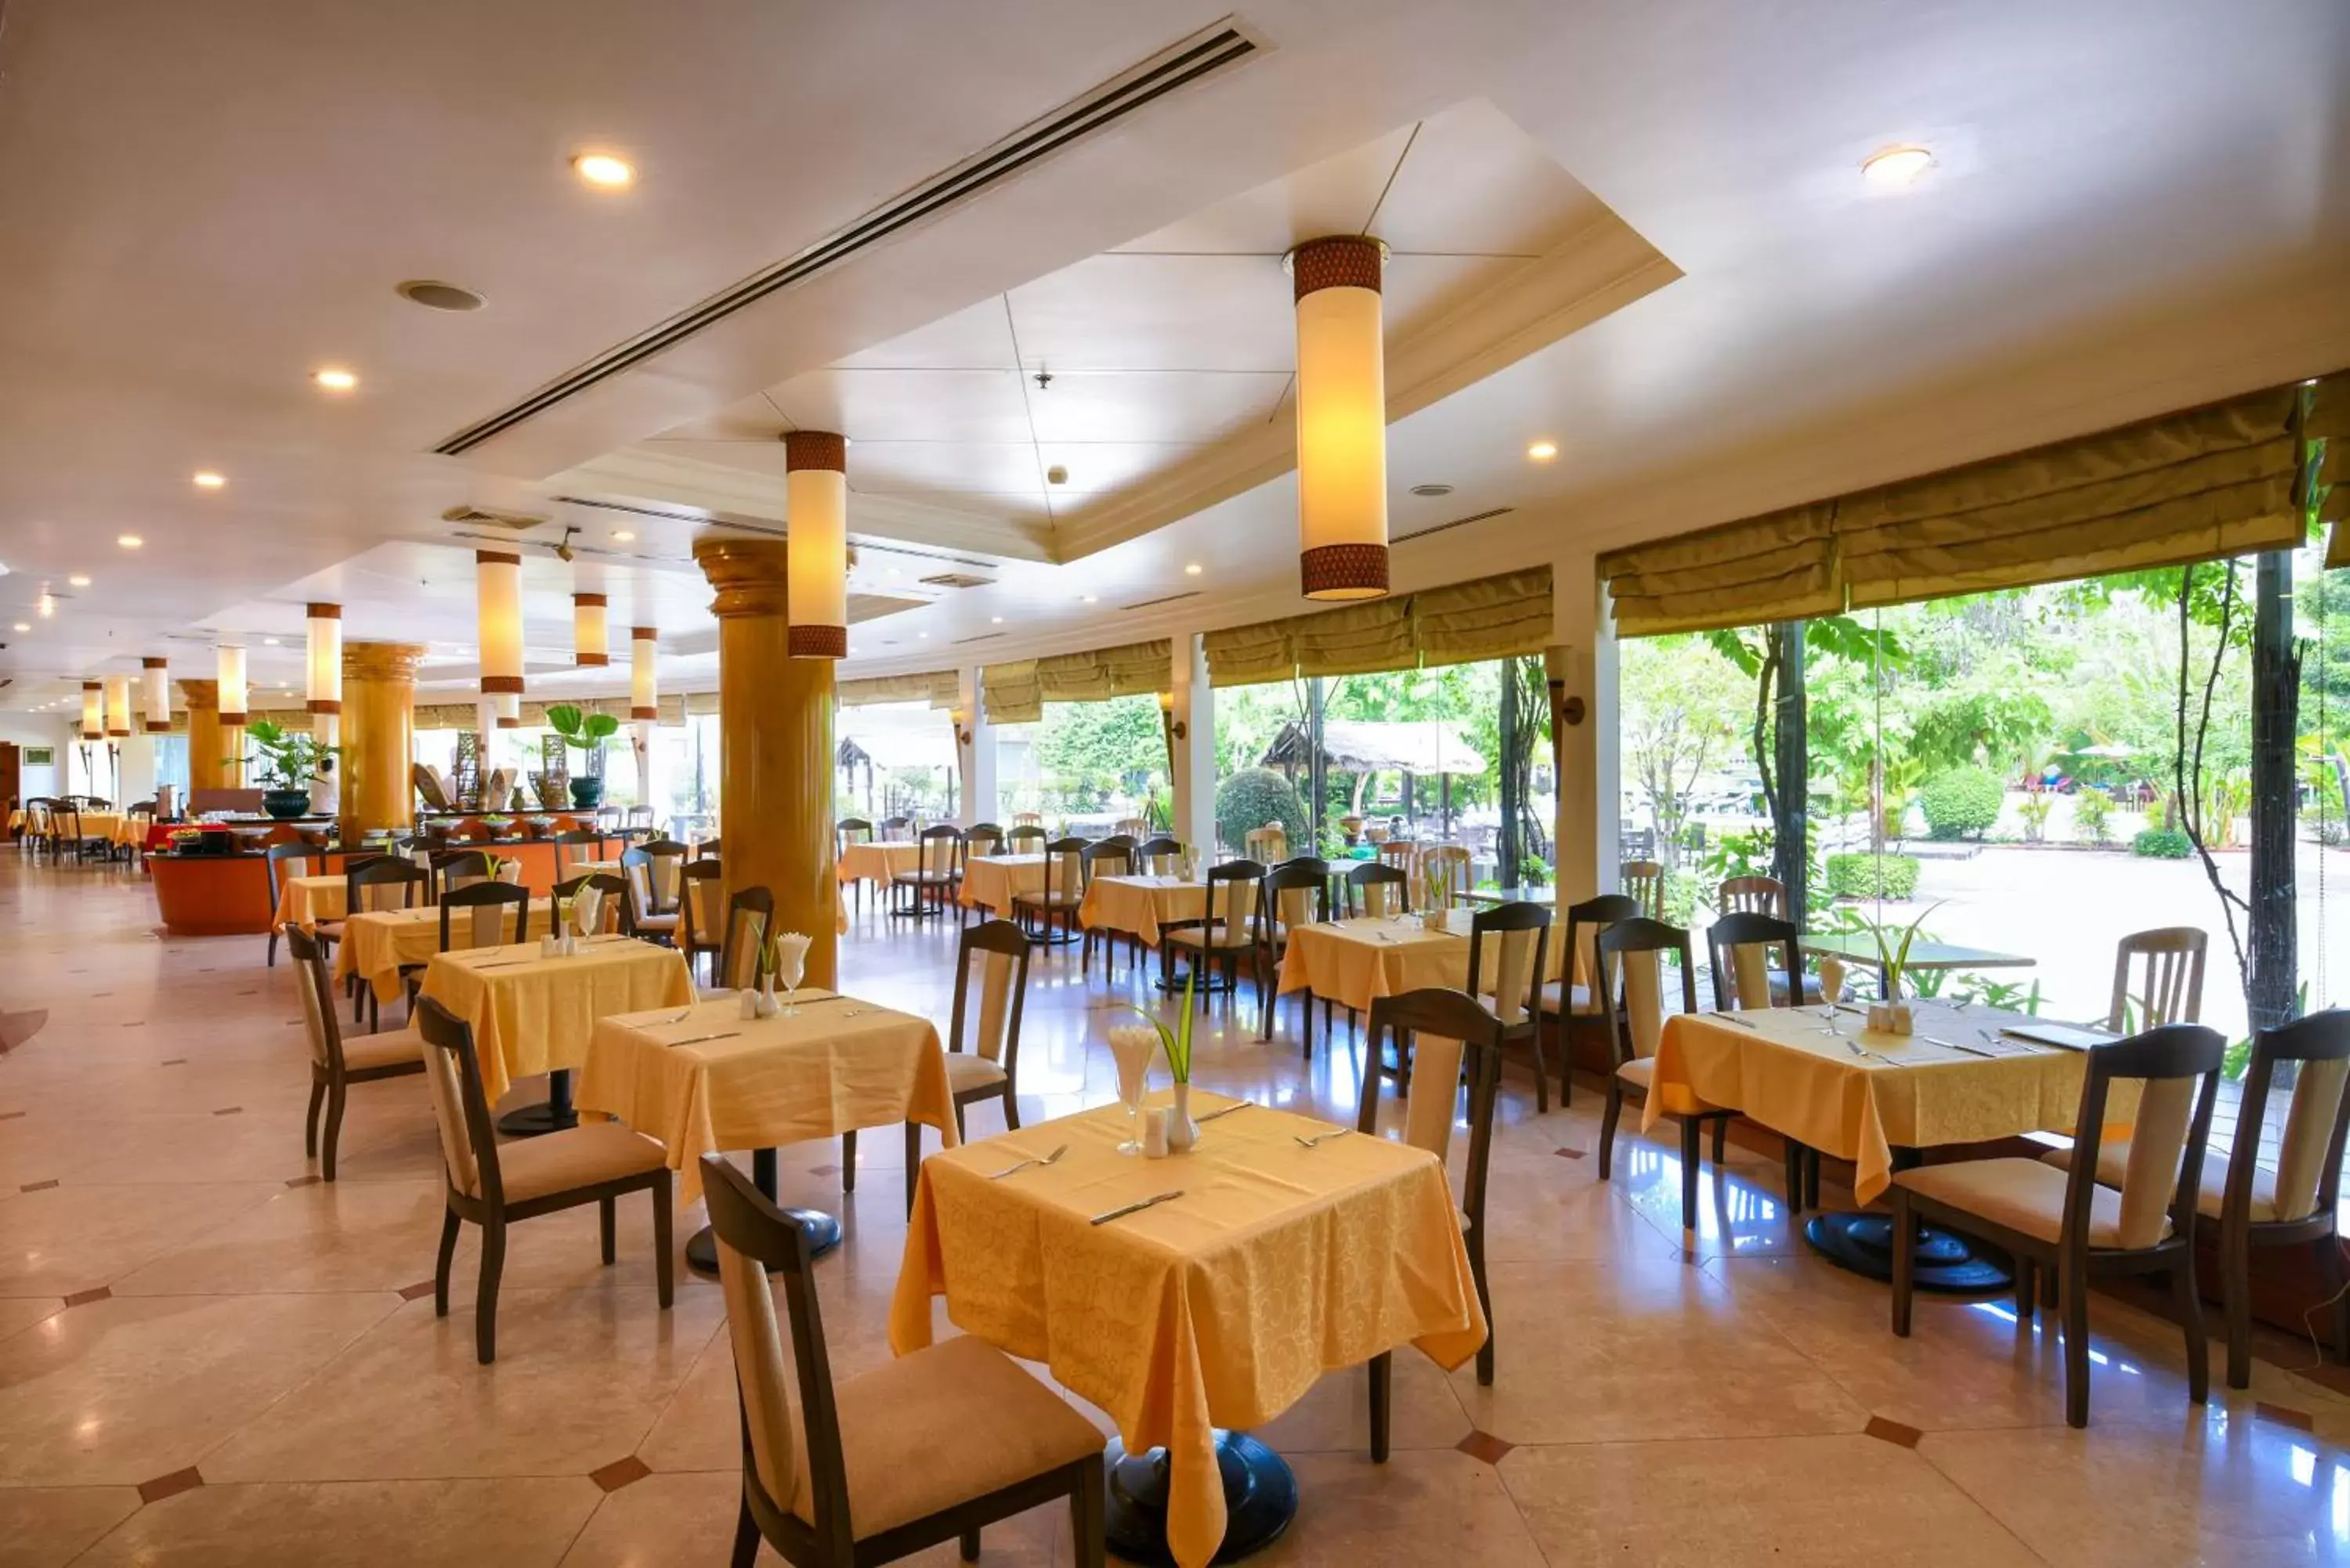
[432, 19, 1264, 456]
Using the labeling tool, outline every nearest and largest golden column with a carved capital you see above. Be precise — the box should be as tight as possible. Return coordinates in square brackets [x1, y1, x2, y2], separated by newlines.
[693, 538, 841, 988]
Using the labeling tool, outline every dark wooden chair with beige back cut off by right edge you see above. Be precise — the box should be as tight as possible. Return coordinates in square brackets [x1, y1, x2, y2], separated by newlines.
[2042, 1009, 2350, 1389]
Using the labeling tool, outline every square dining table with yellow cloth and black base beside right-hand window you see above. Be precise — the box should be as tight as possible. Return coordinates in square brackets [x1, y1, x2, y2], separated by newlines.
[1640, 1002, 2138, 1293]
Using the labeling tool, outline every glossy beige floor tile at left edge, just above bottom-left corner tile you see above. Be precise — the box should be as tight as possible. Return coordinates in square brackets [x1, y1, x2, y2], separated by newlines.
[0, 1293, 400, 1486]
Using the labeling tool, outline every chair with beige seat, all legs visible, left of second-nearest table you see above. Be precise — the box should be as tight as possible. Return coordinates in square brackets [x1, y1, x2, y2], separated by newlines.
[416, 997, 677, 1366]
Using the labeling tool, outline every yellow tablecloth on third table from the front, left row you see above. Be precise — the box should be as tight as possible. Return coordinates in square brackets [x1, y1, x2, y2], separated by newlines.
[425, 936, 693, 1103]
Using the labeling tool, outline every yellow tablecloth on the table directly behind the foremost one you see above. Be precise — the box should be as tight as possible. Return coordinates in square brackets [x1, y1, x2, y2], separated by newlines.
[576, 990, 956, 1204]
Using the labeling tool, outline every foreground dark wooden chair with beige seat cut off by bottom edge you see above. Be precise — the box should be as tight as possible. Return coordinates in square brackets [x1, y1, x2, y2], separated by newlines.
[703, 1154, 1107, 1568]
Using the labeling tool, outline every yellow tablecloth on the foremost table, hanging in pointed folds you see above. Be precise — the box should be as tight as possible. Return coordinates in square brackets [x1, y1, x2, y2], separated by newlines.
[891, 1096, 1485, 1568]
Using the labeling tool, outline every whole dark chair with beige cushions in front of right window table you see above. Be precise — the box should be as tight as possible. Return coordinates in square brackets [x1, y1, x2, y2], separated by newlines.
[1889, 1023, 2228, 1427]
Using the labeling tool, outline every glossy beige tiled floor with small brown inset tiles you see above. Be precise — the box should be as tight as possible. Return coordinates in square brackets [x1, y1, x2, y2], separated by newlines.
[0, 851, 2350, 1568]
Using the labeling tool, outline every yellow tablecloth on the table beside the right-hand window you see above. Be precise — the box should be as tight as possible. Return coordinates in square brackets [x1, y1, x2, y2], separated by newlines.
[1640, 1002, 2138, 1204]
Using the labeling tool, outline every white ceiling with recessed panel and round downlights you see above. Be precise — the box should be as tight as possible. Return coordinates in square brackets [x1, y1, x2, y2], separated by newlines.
[0, 0, 2350, 707]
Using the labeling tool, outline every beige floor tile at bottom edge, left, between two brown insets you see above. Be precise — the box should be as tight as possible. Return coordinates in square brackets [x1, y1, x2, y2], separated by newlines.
[80, 1476, 602, 1568]
